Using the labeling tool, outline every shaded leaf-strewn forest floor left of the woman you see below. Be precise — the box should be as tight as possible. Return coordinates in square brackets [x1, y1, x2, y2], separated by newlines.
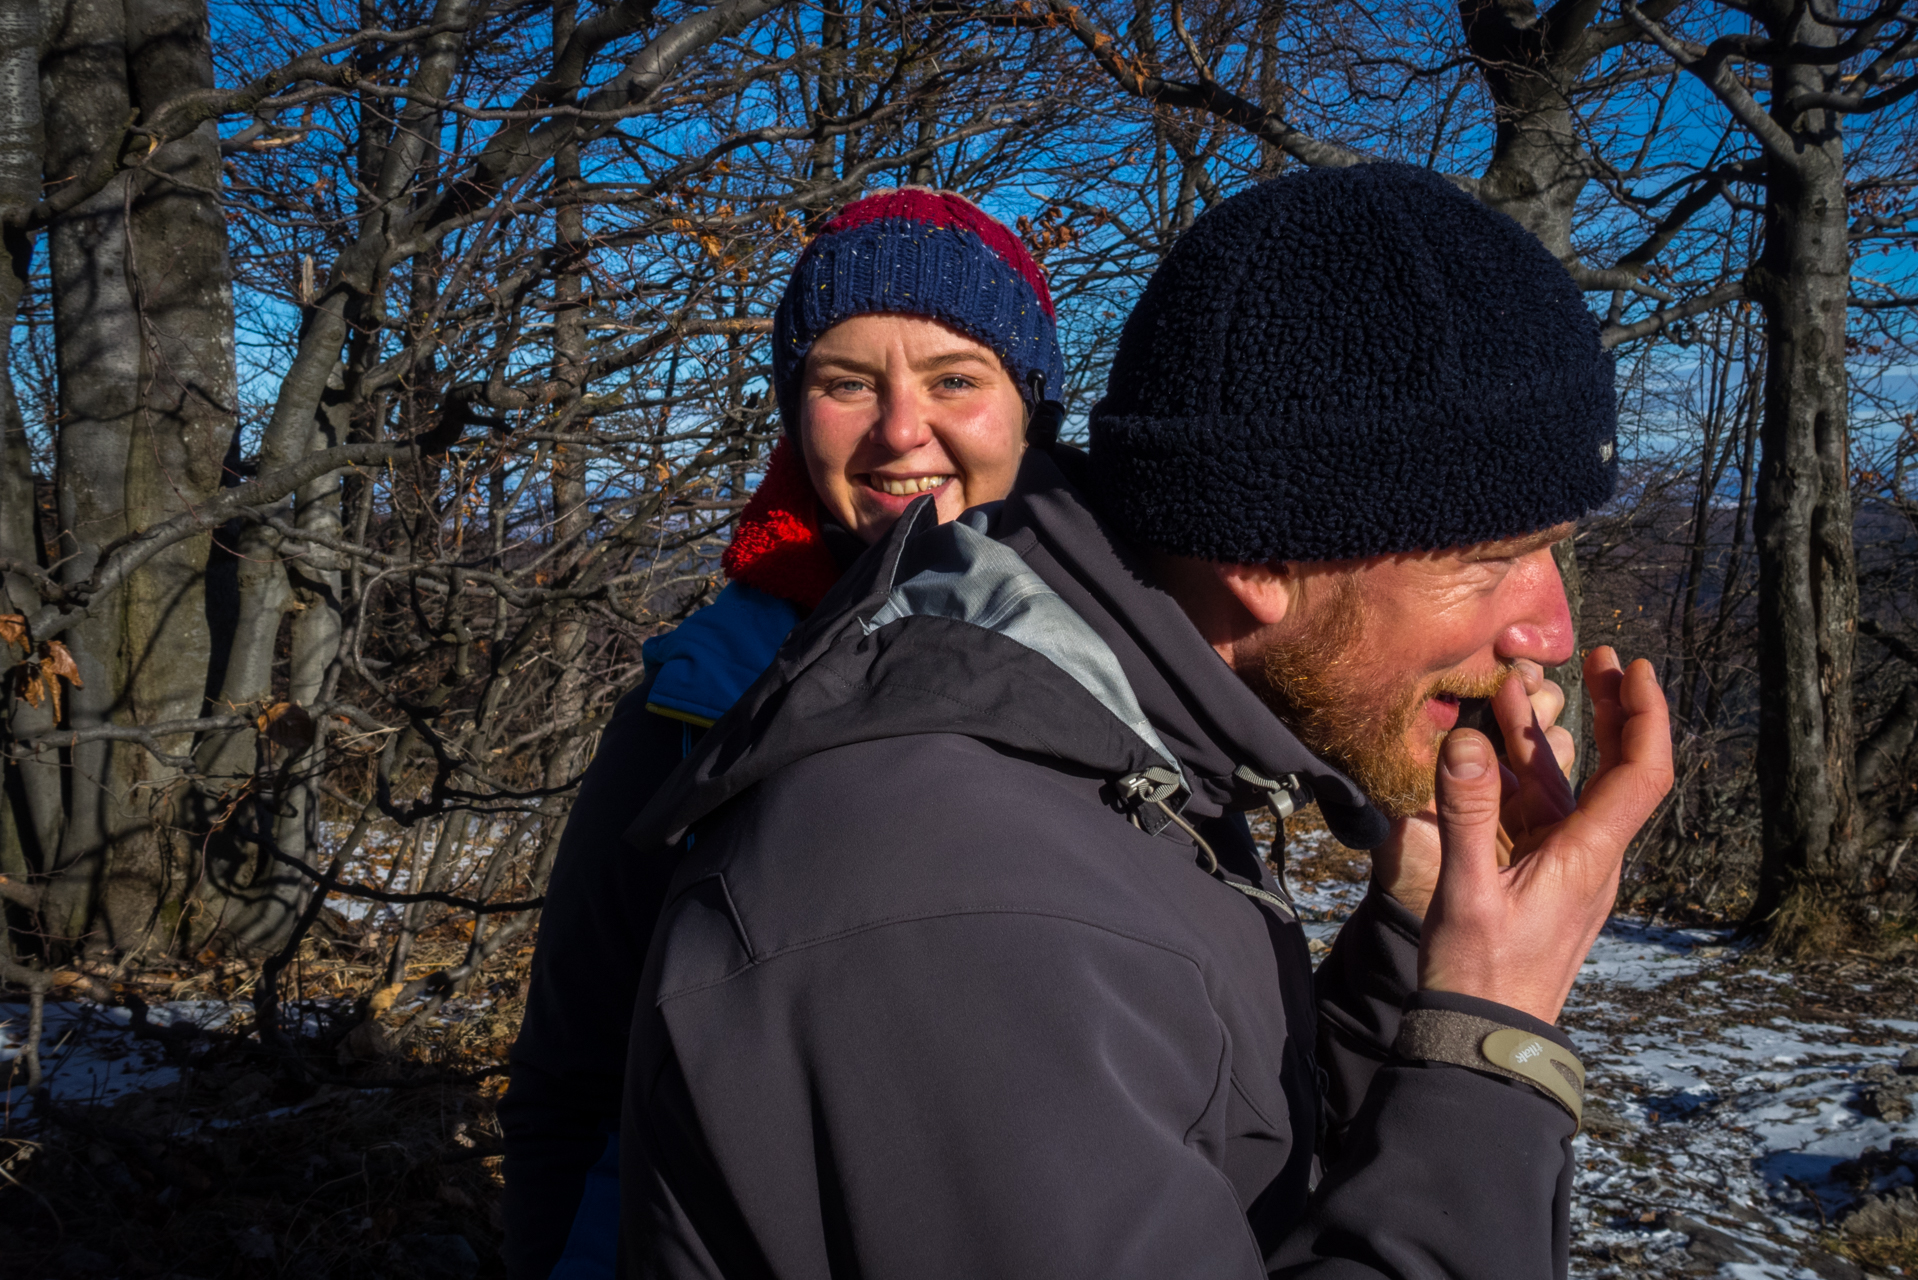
[0, 935, 529, 1280]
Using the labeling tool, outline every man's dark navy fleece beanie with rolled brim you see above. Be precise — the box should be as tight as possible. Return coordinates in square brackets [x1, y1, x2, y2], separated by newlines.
[1091, 163, 1617, 564]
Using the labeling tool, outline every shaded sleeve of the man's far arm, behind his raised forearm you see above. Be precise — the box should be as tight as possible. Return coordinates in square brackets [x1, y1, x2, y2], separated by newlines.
[1314, 885, 1419, 1163]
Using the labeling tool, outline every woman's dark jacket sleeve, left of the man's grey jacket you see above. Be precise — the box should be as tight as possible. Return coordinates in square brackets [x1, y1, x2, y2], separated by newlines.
[499, 681, 698, 1280]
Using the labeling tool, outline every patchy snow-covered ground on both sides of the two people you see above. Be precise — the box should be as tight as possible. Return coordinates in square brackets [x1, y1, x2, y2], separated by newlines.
[0, 837, 1918, 1280]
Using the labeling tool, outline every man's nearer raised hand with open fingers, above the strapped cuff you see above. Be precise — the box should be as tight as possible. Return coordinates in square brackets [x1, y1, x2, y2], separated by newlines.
[1419, 649, 1672, 1023]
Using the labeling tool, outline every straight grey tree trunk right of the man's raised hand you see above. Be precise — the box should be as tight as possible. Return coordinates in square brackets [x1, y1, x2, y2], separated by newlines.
[1747, 6, 1859, 948]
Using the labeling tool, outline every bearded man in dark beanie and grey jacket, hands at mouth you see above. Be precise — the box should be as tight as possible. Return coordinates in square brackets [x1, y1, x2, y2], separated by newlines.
[621, 165, 1671, 1278]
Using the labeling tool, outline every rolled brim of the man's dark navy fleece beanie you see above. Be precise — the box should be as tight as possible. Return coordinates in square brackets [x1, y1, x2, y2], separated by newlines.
[1089, 363, 1617, 564]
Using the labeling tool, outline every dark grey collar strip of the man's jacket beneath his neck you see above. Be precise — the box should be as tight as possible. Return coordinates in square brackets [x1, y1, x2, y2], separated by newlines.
[995, 447, 1389, 848]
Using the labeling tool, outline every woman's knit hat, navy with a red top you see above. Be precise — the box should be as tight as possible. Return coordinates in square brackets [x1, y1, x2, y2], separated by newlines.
[773, 188, 1066, 430]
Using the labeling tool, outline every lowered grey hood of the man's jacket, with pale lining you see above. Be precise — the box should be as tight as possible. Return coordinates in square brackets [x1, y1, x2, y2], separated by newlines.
[627, 449, 1385, 846]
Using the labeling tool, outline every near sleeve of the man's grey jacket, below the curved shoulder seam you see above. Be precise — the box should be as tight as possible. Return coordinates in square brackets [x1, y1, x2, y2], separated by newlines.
[621, 909, 1571, 1280]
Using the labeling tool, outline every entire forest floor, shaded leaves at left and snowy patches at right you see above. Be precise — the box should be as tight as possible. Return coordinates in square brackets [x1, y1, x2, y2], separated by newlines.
[0, 833, 1918, 1280]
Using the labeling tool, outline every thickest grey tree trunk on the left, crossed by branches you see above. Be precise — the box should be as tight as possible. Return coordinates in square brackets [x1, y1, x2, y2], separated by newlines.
[40, 0, 236, 952]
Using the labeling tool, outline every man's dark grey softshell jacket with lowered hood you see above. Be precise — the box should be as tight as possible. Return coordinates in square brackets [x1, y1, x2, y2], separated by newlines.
[621, 451, 1573, 1280]
